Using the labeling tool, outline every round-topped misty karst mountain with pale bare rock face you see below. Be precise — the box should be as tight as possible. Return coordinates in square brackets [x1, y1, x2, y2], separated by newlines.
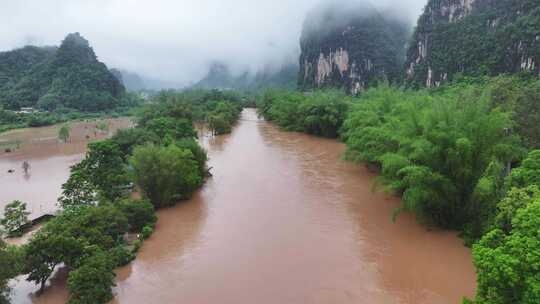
[298, 5, 409, 94]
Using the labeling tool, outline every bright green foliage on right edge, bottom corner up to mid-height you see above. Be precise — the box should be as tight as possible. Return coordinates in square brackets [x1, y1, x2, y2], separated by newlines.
[473, 150, 540, 304]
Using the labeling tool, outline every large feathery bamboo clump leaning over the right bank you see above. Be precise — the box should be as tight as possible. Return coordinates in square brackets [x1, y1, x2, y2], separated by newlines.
[343, 83, 522, 238]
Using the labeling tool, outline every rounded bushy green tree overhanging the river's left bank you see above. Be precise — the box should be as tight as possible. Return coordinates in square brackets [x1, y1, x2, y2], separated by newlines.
[130, 145, 203, 208]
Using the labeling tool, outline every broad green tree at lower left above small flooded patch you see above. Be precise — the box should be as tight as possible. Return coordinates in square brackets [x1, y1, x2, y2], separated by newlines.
[23, 203, 129, 291]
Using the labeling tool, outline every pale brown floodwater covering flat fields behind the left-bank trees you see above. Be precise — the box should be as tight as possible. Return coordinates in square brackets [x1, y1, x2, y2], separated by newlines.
[0, 118, 131, 219]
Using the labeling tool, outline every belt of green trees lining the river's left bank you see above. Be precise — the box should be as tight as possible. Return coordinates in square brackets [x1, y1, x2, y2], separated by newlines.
[0, 91, 242, 303]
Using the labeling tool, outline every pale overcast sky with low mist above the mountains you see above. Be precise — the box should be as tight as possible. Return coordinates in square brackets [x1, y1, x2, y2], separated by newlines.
[0, 0, 427, 83]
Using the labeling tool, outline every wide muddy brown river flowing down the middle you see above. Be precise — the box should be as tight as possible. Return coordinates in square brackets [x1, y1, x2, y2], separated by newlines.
[5, 109, 476, 304]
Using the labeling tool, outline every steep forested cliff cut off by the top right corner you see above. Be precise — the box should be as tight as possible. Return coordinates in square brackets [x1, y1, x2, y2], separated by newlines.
[406, 0, 540, 87]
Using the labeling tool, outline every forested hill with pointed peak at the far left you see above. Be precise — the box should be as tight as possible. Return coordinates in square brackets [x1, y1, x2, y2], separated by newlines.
[0, 33, 125, 112]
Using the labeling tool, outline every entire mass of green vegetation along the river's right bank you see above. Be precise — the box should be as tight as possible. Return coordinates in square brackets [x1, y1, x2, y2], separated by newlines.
[258, 76, 540, 304]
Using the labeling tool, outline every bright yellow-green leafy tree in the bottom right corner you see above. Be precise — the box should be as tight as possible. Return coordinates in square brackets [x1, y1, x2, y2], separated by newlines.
[473, 200, 540, 304]
